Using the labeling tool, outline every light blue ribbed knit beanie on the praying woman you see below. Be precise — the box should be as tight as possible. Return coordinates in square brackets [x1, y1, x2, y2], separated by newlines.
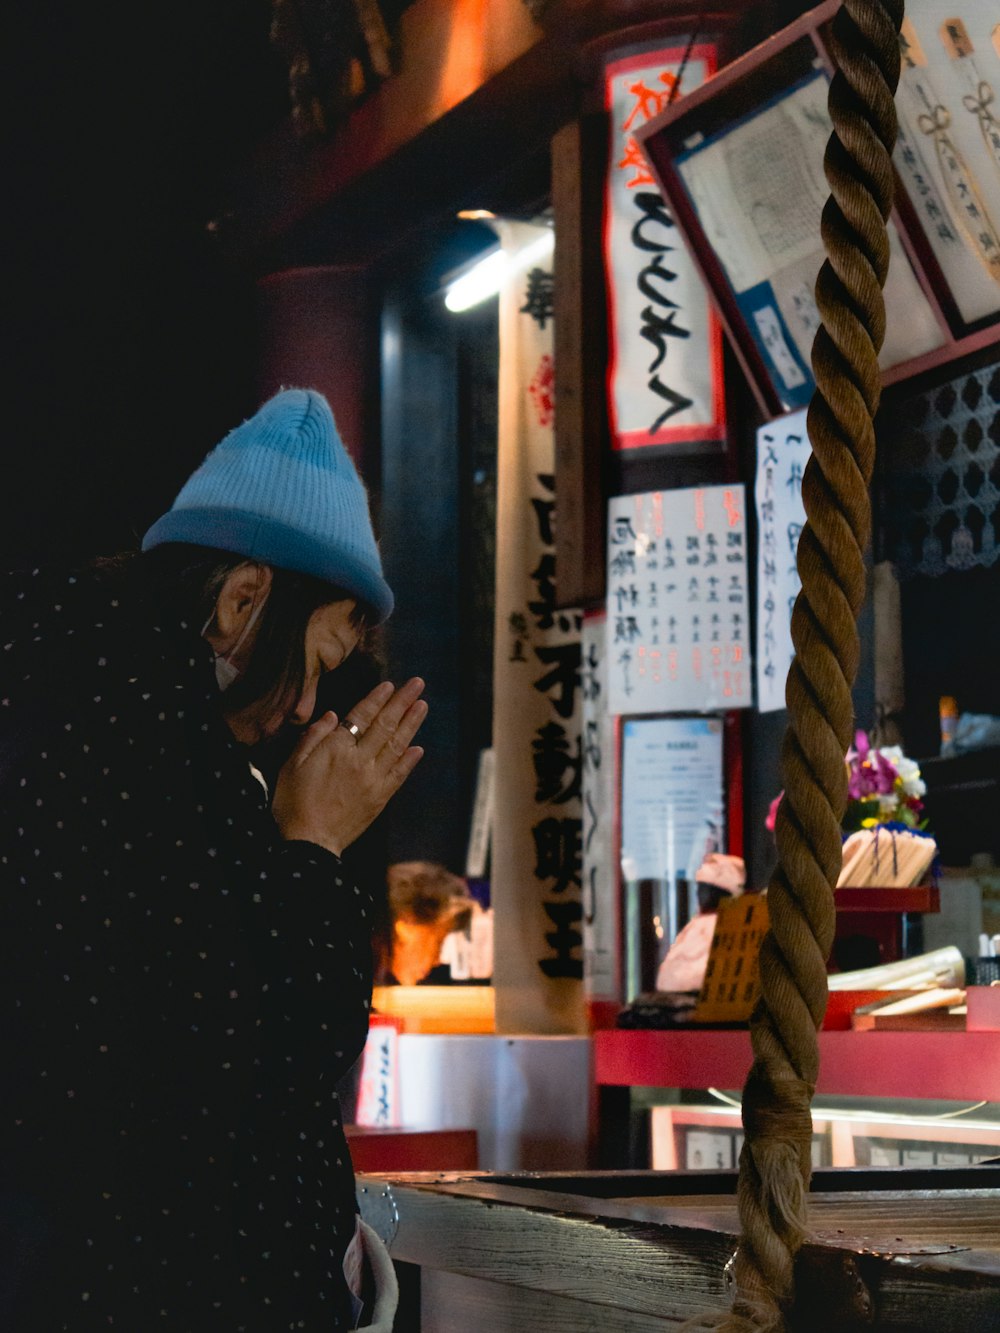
[143, 389, 393, 621]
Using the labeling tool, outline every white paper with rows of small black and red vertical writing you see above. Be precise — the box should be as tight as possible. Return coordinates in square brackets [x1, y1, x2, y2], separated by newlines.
[607, 484, 752, 713]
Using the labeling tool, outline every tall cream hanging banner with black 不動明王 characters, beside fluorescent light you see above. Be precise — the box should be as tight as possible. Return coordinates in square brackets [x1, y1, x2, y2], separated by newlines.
[491, 223, 585, 1033]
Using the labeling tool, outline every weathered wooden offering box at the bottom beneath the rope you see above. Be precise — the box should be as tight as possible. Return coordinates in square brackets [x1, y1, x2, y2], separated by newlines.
[359, 1165, 1000, 1333]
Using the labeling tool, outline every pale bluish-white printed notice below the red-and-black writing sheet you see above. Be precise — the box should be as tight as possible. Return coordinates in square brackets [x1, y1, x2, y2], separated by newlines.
[621, 717, 725, 884]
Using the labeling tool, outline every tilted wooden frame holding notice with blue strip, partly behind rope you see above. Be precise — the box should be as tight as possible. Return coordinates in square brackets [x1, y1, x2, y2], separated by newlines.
[637, 0, 1000, 419]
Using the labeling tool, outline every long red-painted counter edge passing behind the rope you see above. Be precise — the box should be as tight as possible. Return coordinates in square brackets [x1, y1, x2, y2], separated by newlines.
[593, 1028, 1000, 1101]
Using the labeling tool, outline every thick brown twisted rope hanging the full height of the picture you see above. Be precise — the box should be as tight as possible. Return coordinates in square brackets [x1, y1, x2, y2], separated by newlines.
[693, 0, 903, 1333]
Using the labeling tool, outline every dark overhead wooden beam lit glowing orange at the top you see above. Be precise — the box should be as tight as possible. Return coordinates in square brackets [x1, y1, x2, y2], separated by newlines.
[211, 0, 771, 264]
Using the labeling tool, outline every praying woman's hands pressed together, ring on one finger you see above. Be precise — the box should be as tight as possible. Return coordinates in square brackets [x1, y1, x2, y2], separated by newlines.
[272, 676, 427, 856]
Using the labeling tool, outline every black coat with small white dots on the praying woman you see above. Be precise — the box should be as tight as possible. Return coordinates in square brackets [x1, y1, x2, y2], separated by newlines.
[0, 559, 371, 1333]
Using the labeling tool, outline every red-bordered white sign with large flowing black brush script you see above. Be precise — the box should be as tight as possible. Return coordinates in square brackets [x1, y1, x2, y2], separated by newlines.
[604, 45, 725, 449]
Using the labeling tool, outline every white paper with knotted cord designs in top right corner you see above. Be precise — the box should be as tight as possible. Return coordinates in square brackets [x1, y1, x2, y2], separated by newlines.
[895, 0, 1000, 323]
